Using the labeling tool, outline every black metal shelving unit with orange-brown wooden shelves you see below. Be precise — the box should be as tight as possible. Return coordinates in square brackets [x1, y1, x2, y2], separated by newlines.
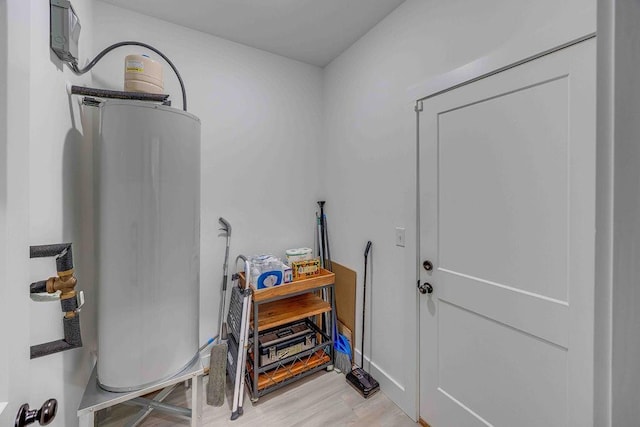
[240, 269, 335, 402]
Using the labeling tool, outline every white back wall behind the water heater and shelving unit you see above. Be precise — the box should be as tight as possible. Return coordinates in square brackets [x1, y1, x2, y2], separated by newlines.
[93, 2, 322, 352]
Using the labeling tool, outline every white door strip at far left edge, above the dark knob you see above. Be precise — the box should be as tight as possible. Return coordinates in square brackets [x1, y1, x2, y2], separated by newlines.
[0, 0, 32, 425]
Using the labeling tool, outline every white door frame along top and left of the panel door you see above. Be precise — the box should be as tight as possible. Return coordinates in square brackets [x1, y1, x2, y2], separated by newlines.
[408, 30, 612, 427]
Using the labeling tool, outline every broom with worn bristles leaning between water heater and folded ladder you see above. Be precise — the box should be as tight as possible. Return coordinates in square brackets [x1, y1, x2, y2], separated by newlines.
[207, 217, 231, 406]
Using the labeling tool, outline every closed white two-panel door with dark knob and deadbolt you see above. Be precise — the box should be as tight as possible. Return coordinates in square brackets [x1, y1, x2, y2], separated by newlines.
[419, 39, 595, 427]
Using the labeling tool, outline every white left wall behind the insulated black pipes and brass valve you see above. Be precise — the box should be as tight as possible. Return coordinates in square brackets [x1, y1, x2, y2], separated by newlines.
[25, 0, 96, 425]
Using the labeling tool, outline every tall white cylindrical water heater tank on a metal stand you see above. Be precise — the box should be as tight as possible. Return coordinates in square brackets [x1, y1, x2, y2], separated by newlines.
[94, 100, 200, 392]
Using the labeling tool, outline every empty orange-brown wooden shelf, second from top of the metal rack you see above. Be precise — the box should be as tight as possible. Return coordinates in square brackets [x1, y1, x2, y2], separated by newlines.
[258, 292, 331, 331]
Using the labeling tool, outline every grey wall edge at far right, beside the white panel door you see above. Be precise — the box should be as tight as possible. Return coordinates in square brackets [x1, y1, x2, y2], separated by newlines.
[598, 0, 640, 426]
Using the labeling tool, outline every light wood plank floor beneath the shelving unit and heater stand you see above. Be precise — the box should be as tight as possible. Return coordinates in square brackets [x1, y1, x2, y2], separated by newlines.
[97, 371, 417, 427]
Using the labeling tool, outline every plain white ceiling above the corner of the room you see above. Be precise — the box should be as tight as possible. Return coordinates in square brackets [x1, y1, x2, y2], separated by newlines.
[96, 0, 404, 67]
